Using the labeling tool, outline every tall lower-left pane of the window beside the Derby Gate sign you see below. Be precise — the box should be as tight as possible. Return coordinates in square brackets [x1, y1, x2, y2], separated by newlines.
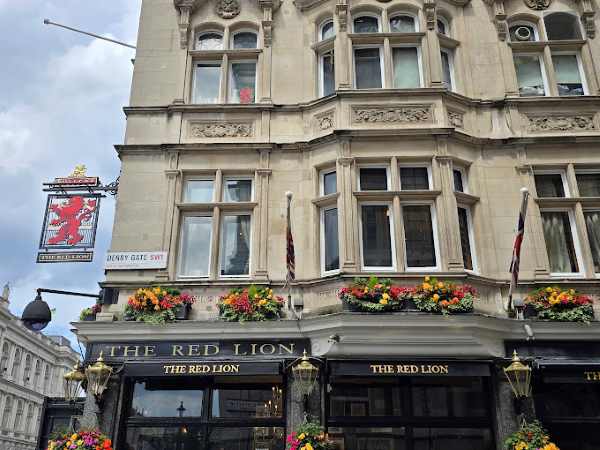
[180, 217, 212, 277]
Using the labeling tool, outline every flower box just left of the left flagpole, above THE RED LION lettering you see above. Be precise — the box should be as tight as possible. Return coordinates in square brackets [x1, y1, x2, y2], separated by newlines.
[218, 285, 284, 322]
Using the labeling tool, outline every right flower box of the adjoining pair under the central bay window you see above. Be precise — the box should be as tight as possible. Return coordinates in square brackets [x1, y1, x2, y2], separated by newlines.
[413, 277, 477, 314]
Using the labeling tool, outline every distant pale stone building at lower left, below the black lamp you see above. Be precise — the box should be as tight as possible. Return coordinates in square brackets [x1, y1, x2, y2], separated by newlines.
[0, 286, 80, 450]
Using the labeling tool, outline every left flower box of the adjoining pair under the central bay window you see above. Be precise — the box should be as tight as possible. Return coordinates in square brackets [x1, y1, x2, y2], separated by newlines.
[338, 277, 413, 313]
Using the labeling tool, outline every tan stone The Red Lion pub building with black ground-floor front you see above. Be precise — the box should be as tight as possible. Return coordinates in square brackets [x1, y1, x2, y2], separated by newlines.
[75, 0, 600, 450]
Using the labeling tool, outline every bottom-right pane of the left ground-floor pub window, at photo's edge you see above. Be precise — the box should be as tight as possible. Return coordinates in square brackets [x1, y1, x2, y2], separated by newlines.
[208, 427, 285, 450]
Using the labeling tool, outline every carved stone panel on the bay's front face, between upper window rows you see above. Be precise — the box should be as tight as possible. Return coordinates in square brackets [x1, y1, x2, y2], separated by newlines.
[352, 105, 433, 123]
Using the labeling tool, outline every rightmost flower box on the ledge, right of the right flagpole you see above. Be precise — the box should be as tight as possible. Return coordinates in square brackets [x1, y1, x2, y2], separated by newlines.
[525, 286, 594, 323]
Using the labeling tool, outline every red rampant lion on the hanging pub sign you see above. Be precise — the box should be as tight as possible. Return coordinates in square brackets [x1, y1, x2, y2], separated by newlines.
[48, 196, 97, 245]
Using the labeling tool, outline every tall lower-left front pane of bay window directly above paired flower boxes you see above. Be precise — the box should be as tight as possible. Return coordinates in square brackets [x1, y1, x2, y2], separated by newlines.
[362, 205, 392, 267]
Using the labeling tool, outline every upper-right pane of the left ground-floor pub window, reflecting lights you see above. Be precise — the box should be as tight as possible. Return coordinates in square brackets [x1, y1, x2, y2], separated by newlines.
[211, 386, 283, 419]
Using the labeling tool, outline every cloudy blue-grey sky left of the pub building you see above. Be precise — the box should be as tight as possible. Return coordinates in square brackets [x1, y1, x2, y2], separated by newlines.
[0, 0, 141, 347]
